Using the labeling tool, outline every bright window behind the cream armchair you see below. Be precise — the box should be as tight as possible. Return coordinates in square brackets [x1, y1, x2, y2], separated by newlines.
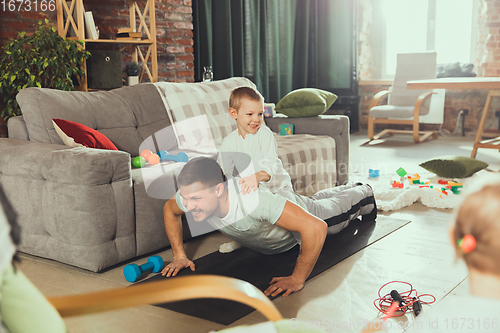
[380, 0, 478, 78]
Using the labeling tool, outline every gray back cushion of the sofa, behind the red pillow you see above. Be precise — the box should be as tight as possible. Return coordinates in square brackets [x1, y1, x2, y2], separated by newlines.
[16, 84, 177, 155]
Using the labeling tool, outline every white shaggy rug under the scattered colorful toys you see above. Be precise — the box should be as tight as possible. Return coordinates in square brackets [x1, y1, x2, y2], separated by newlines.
[349, 170, 465, 211]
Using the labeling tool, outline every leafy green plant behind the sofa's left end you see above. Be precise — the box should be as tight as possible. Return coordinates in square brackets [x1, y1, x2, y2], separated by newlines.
[0, 19, 90, 120]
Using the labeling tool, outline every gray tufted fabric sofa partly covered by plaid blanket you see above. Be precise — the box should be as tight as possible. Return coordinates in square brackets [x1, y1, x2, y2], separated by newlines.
[0, 79, 349, 272]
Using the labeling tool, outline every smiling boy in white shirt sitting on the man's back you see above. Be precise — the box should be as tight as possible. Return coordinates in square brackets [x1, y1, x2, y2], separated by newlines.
[218, 87, 296, 252]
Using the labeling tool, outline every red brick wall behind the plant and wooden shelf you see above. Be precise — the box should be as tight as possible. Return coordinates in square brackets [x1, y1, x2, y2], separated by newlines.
[0, 0, 194, 82]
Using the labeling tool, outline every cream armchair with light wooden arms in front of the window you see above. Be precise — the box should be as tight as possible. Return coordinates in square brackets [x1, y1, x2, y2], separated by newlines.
[368, 52, 445, 143]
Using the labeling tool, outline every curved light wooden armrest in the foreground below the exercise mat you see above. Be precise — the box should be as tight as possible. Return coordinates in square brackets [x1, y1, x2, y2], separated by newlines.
[49, 275, 283, 321]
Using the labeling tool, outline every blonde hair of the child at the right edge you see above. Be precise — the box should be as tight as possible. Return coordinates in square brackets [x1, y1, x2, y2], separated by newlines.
[452, 175, 500, 276]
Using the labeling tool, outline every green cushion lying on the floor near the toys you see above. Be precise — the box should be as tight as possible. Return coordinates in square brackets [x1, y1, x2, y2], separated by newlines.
[420, 156, 488, 178]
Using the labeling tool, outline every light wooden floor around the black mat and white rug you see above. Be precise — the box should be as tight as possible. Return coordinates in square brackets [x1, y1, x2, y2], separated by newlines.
[19, 134, 500, 333]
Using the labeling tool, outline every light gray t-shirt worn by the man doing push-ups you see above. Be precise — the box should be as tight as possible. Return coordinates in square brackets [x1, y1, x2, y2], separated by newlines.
[176, 178, 305, 254]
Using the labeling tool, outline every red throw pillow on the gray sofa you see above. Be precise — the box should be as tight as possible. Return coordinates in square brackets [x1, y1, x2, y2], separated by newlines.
[52, 119, 118, 150]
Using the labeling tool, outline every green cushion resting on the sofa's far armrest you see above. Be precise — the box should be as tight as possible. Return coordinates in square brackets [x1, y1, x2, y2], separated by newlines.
[275, 88, 337, 117]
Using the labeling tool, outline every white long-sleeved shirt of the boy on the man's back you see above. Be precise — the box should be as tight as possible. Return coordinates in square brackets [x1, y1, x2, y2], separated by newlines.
[218, 125, 292, 193]
